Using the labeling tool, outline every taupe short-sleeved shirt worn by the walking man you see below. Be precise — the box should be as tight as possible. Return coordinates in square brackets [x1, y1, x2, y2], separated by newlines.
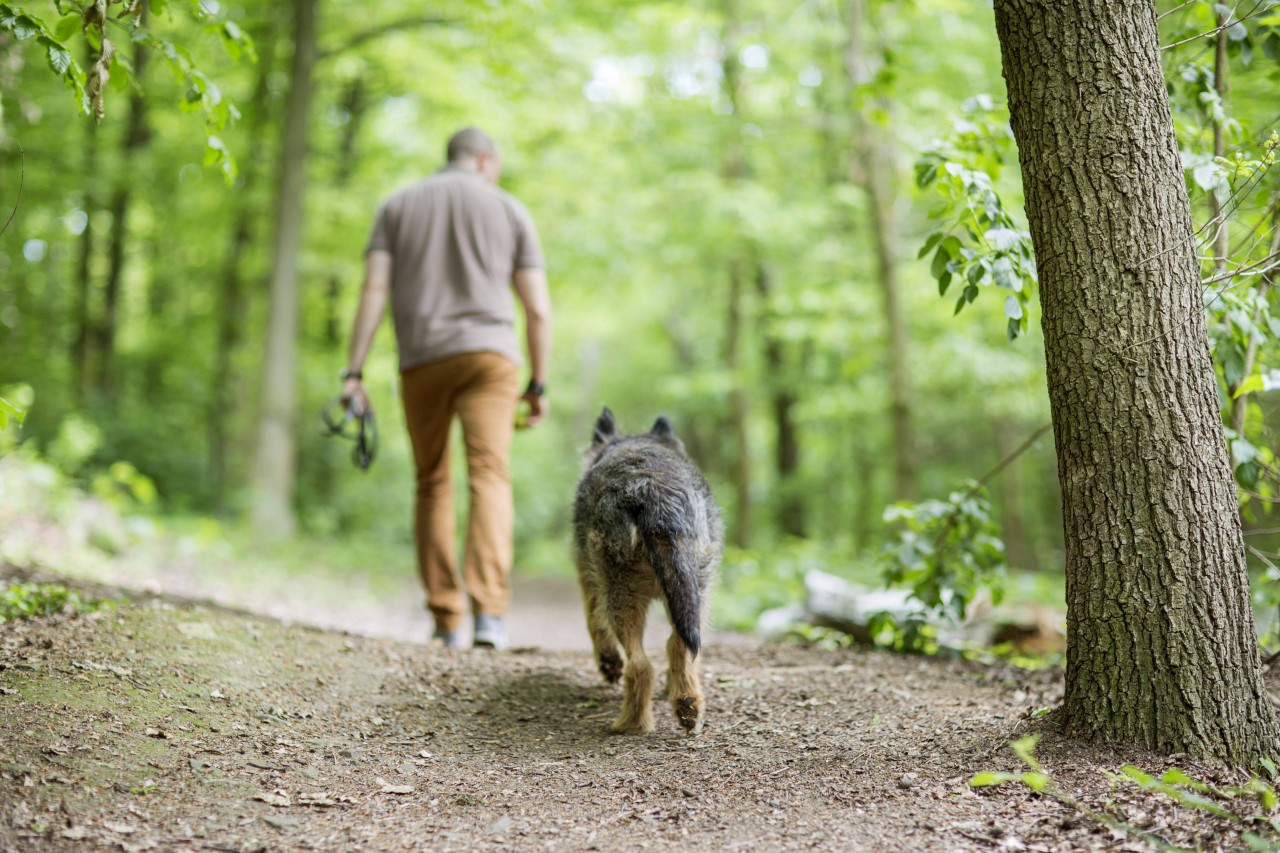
[365, 167, 543, 370]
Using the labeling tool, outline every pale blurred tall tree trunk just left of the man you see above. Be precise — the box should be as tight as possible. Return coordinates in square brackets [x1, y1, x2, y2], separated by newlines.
[250, 0, 317, 535]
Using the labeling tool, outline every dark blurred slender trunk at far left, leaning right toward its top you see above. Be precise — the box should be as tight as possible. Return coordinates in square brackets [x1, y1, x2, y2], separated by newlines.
[93, 0, 150, 398]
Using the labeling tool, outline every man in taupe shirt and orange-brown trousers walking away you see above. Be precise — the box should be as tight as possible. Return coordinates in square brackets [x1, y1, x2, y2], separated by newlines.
[342, 127, 552, 648]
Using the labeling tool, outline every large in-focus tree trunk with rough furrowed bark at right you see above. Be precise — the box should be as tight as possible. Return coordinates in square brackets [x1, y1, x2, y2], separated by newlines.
[996, 0, 1280, 762]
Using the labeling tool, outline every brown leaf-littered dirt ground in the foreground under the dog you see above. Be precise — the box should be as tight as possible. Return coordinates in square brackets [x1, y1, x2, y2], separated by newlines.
[0, 567, 1280, 850]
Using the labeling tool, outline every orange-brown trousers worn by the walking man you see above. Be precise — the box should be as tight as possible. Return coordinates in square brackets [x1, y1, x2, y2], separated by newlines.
[401, 352, 518, 631]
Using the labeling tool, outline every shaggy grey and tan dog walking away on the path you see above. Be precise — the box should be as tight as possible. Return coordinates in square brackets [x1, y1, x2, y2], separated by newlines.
[573, 407, 724, 734]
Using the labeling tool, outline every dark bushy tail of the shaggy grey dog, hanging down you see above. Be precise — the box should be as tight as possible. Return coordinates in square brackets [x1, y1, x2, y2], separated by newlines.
[631, 483, 703, 657]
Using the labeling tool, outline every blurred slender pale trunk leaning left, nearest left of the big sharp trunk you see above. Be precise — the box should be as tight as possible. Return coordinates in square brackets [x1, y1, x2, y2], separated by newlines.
[845, 0, 918, 500]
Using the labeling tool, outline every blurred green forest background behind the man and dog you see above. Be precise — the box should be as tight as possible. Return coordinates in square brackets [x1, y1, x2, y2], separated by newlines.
[0, 0, 1280, 637]
